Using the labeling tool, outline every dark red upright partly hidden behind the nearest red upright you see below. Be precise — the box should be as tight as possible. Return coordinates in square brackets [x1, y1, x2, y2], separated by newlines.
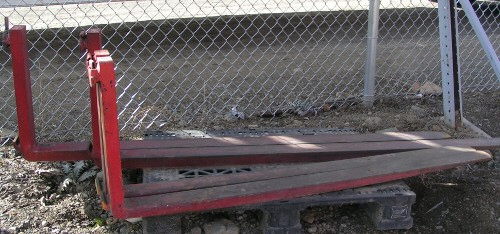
[83, 28, 102, 164]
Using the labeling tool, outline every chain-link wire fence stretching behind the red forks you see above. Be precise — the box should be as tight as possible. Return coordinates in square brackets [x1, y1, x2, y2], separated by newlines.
[0, 0, 500, 145]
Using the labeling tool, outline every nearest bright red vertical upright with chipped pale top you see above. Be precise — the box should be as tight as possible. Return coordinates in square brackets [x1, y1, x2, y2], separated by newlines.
[91, 50, 126, 218]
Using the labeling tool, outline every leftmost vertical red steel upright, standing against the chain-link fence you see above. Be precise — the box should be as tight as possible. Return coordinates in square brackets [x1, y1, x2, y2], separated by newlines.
[9, 25, 36, 157]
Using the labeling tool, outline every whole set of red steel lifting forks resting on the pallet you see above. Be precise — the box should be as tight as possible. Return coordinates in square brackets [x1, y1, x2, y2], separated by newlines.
[9, 26, 500, 218]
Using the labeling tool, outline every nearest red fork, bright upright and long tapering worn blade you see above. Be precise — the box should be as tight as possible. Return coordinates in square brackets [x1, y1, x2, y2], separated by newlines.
[83, 30, 491, 218]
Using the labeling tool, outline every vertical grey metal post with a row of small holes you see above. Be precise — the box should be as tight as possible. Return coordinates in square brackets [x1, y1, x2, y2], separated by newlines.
[438, 0, 462, 128]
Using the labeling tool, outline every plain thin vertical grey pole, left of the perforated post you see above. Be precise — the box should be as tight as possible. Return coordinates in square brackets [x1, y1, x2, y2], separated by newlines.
[363, 0, 380, 107]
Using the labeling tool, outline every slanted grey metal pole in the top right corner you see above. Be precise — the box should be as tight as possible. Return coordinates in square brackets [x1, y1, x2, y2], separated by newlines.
[459, 0, 500, 82]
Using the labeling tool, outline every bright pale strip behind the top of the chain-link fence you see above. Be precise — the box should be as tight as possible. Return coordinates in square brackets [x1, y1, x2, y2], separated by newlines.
[0, 0, 437, 30]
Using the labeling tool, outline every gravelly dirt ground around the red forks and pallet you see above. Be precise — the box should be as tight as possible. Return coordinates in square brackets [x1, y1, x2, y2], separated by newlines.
[0, 92, 500, 233]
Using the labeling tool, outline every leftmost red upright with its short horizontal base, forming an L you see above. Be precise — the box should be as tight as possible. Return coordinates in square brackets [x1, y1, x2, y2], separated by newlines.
[8, 25, 91, 161]
